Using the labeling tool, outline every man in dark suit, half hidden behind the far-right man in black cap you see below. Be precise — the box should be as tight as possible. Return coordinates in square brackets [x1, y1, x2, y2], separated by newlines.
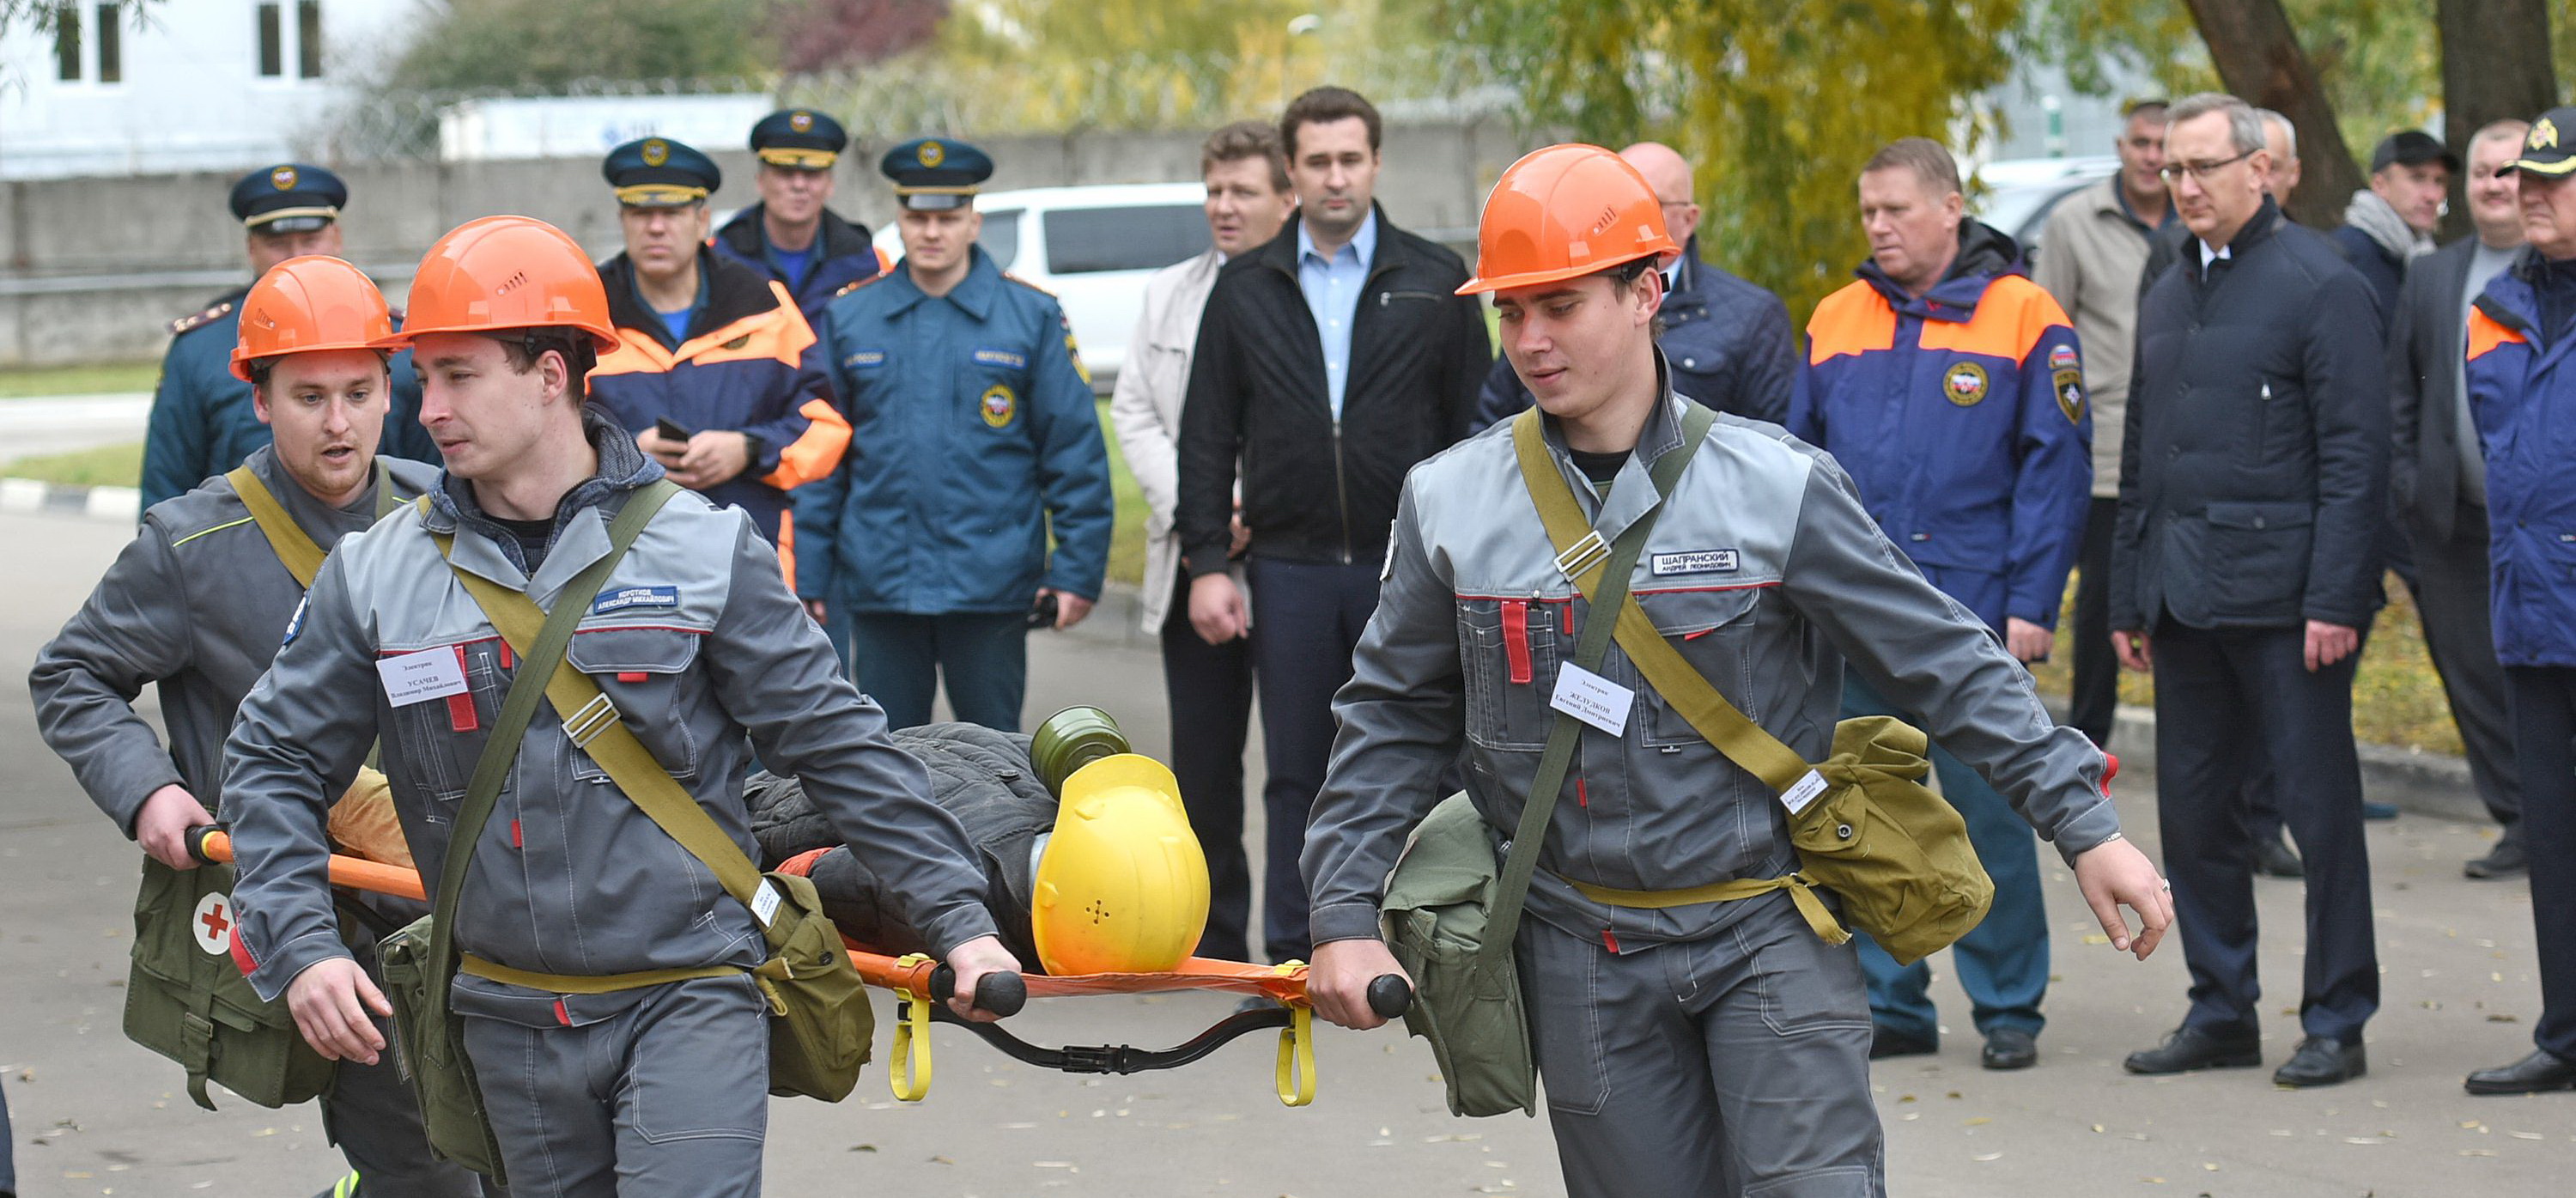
[2388, 121, 2530, 879]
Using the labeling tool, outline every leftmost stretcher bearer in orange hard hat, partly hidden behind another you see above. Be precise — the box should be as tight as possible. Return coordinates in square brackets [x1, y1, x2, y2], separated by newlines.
[28, 255, 477, 1198]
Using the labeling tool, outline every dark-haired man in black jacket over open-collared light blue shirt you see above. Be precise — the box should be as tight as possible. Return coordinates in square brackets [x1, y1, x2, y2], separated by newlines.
[1175, 88, 1494, 961]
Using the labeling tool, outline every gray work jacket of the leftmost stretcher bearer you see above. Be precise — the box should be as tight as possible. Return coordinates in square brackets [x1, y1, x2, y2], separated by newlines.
[26, 446, 438, 837]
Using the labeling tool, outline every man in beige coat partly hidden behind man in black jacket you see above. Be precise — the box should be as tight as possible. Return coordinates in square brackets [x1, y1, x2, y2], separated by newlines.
[1110, 121, 1296, 961]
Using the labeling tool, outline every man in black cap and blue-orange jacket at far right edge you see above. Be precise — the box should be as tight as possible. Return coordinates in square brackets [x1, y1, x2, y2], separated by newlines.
[2468, 108, 2576, 1095]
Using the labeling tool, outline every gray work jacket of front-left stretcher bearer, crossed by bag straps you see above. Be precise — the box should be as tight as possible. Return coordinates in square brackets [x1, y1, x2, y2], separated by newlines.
[224, 410, 994, 1028]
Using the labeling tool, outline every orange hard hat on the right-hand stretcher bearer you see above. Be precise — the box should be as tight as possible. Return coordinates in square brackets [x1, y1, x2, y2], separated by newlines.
[1458, 144, 1682, 296]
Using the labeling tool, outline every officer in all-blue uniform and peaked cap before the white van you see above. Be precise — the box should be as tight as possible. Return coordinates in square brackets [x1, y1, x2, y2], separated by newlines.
[796, 137, 1110, 732]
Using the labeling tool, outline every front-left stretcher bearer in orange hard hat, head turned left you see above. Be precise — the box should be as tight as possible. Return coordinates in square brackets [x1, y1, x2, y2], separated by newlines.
[224, 216, 1018, 1198]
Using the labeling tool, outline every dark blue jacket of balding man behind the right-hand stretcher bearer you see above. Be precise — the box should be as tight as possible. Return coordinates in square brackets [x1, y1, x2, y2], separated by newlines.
[1476, 237, 1798, 428]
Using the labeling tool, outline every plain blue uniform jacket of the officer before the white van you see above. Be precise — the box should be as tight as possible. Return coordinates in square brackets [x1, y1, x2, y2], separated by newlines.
[796, 247, 1110, 616]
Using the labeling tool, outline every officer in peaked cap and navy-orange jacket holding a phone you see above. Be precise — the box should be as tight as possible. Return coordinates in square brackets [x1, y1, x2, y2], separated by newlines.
[590, 137, 850, 551]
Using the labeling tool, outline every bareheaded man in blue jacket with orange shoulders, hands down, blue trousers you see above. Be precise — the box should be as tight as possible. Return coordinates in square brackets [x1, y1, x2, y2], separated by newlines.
[1788, 137, 2092, 1069]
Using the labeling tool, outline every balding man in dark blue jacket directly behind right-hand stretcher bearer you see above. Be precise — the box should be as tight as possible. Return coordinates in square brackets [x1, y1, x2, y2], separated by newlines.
[1476, 142, 1798, 428]
